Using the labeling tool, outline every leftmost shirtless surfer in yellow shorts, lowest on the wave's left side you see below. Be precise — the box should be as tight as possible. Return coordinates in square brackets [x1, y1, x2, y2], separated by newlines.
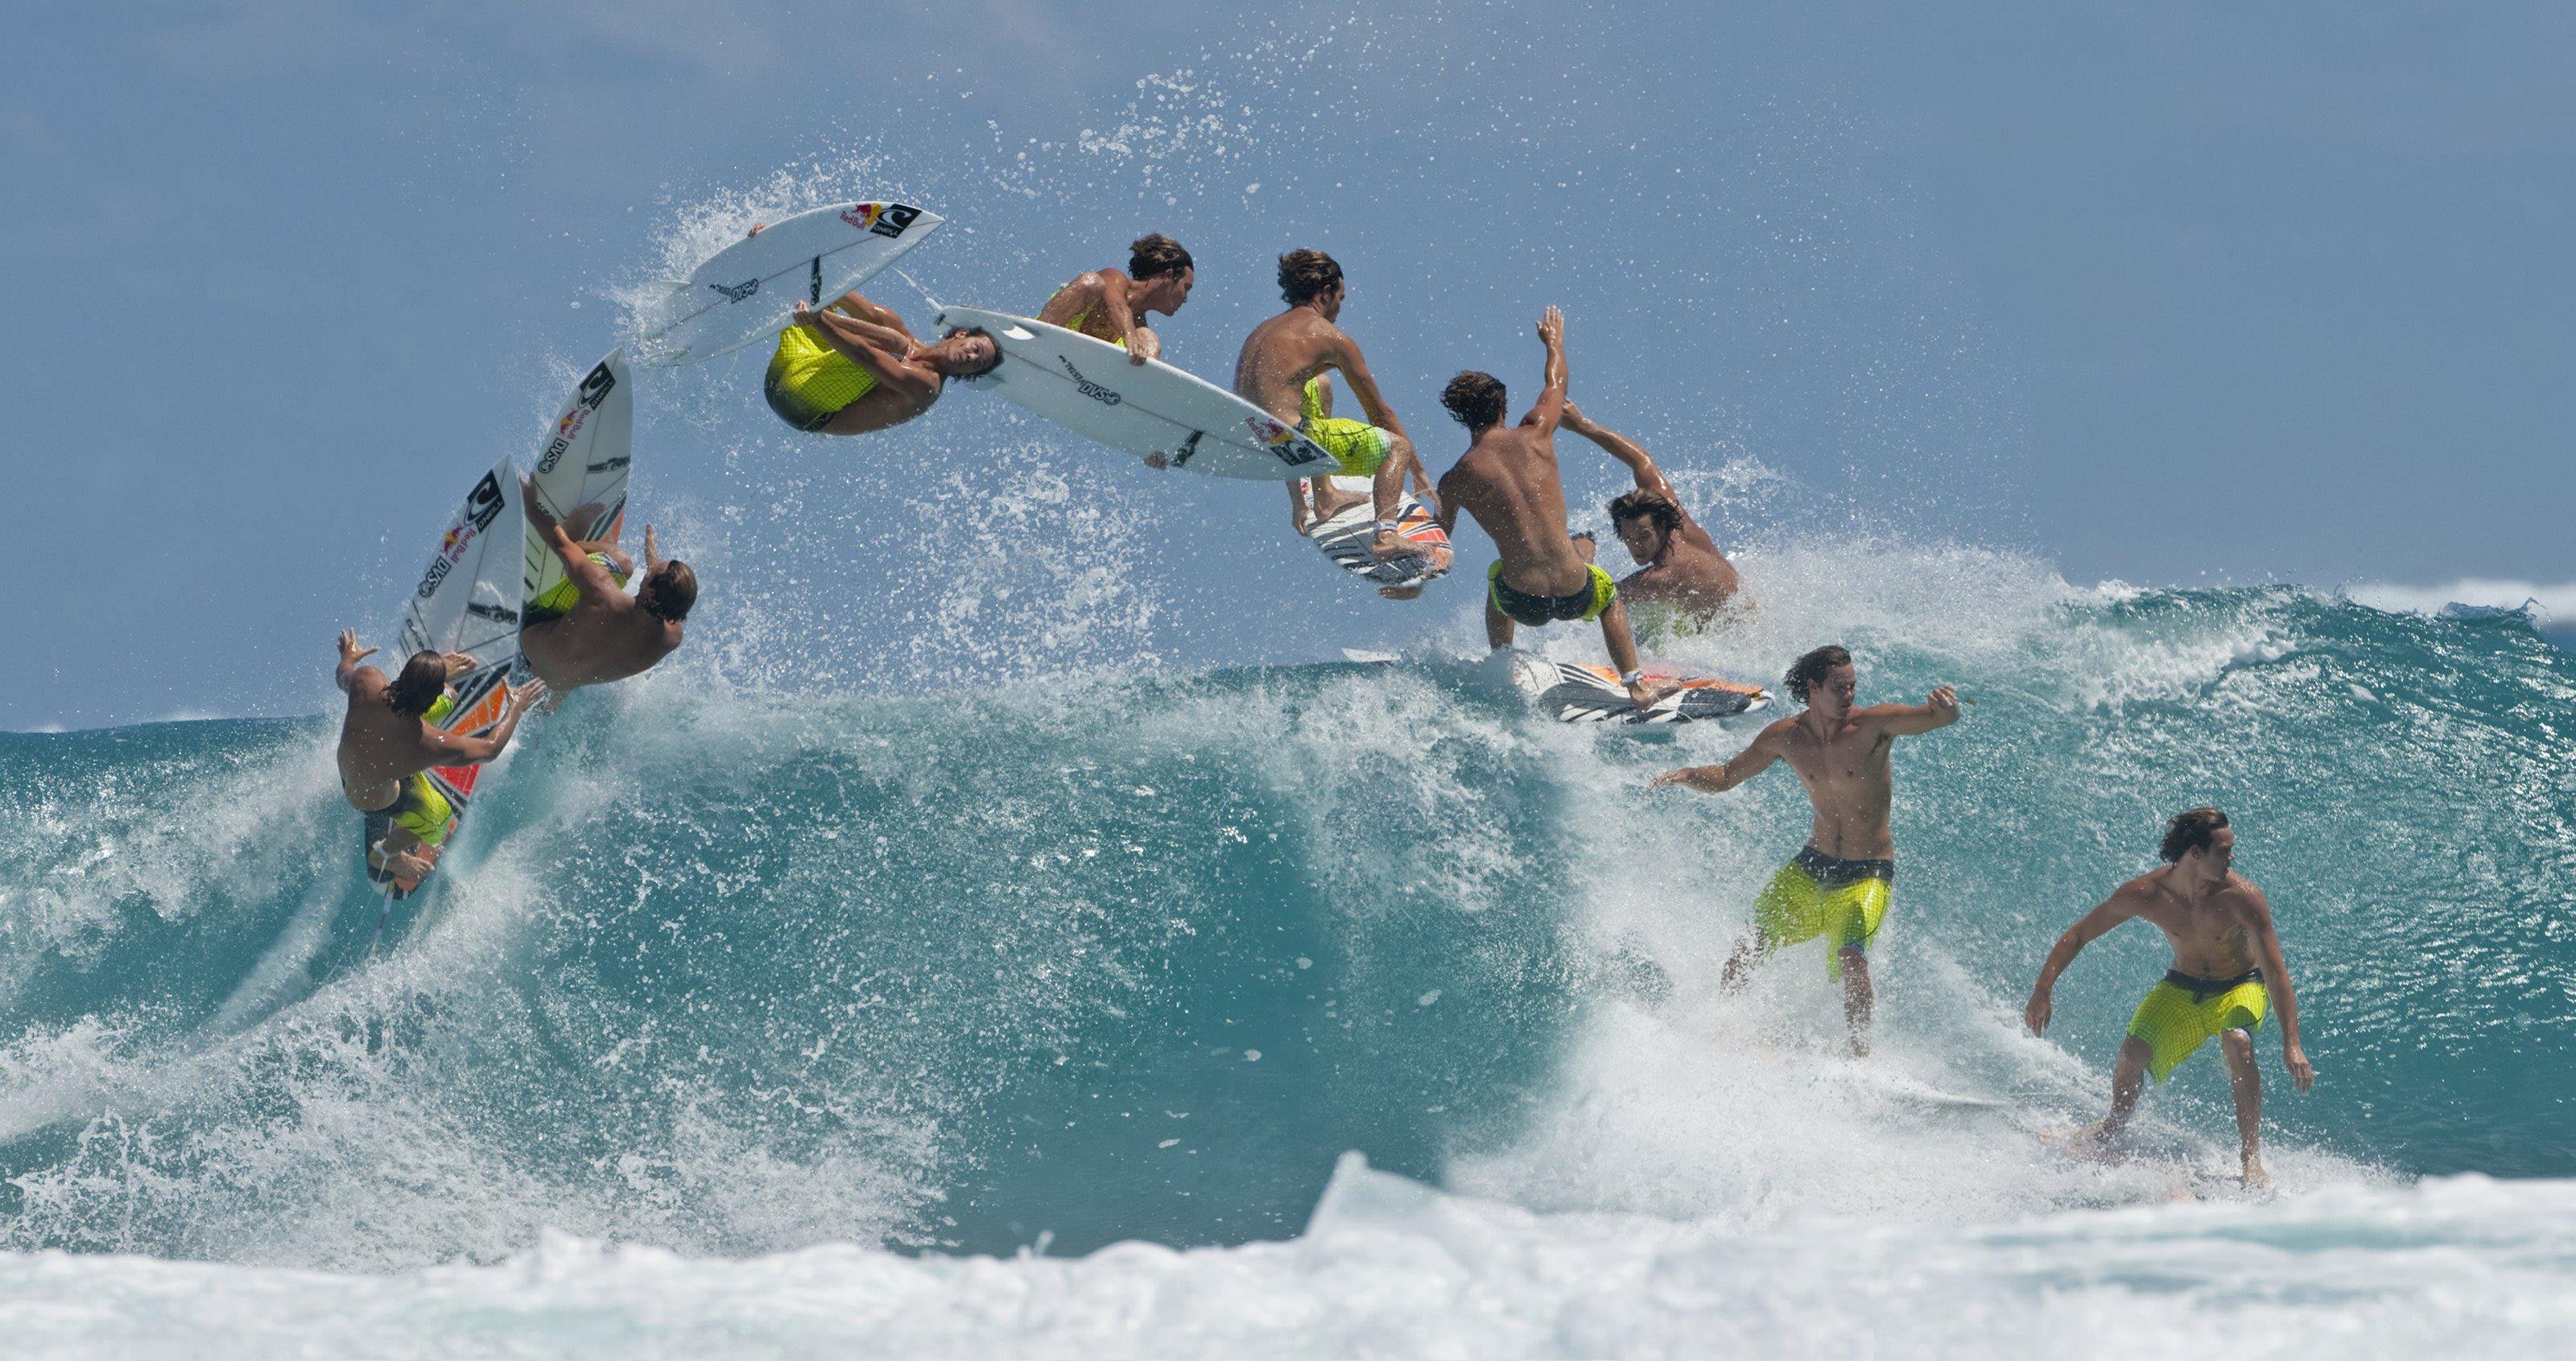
[332, 629, 543, 892]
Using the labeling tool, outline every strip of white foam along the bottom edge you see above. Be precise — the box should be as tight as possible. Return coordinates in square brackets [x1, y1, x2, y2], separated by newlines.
[0, 1155, 2576, 1359]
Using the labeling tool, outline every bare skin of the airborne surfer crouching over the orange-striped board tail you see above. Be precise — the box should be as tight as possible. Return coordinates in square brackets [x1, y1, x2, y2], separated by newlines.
[1234, 278, 1440, 559]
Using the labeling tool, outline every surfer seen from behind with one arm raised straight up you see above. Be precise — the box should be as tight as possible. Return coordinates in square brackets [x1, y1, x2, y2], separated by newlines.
[1432, 307, 1674, 709]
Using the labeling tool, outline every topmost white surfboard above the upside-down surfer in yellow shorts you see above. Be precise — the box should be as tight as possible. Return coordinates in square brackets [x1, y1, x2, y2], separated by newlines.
[636, 199, 945, 366]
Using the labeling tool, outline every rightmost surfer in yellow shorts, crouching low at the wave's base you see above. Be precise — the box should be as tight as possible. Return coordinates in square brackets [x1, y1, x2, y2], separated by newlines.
[2022, 806, 2316, 1186]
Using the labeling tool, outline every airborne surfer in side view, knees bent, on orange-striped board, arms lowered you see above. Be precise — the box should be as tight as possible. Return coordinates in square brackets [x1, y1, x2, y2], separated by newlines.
[1234, 250, 1438, 559]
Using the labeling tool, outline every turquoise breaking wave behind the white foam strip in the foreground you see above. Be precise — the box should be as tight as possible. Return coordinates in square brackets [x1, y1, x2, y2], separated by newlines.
[0, 564, 2576, 1271]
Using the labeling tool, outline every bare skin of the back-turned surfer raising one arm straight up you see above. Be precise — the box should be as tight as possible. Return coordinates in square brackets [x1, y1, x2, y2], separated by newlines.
[1440, 307, 1679, 709]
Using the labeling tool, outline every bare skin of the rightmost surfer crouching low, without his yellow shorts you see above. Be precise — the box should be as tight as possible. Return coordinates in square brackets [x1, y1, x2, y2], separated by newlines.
[2022, 827, 2316, 1186]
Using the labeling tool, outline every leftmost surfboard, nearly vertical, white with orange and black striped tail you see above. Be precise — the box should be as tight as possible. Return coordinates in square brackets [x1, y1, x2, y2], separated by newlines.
[376, 456, 526, 897]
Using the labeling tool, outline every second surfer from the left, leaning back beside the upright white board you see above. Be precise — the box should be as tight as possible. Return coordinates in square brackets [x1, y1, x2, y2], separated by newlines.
[518, 480, 698, 696]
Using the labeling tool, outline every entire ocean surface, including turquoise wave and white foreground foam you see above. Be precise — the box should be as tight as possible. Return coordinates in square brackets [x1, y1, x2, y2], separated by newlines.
[0, 562, 2576, 1356]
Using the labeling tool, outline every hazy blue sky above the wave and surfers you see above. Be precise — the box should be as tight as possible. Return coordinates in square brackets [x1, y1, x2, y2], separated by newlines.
[0, 0, 2576, 727]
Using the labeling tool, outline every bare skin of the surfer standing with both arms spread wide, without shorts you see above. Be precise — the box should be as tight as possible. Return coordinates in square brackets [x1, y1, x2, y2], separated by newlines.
[1646, 665, 1958, 1054]
